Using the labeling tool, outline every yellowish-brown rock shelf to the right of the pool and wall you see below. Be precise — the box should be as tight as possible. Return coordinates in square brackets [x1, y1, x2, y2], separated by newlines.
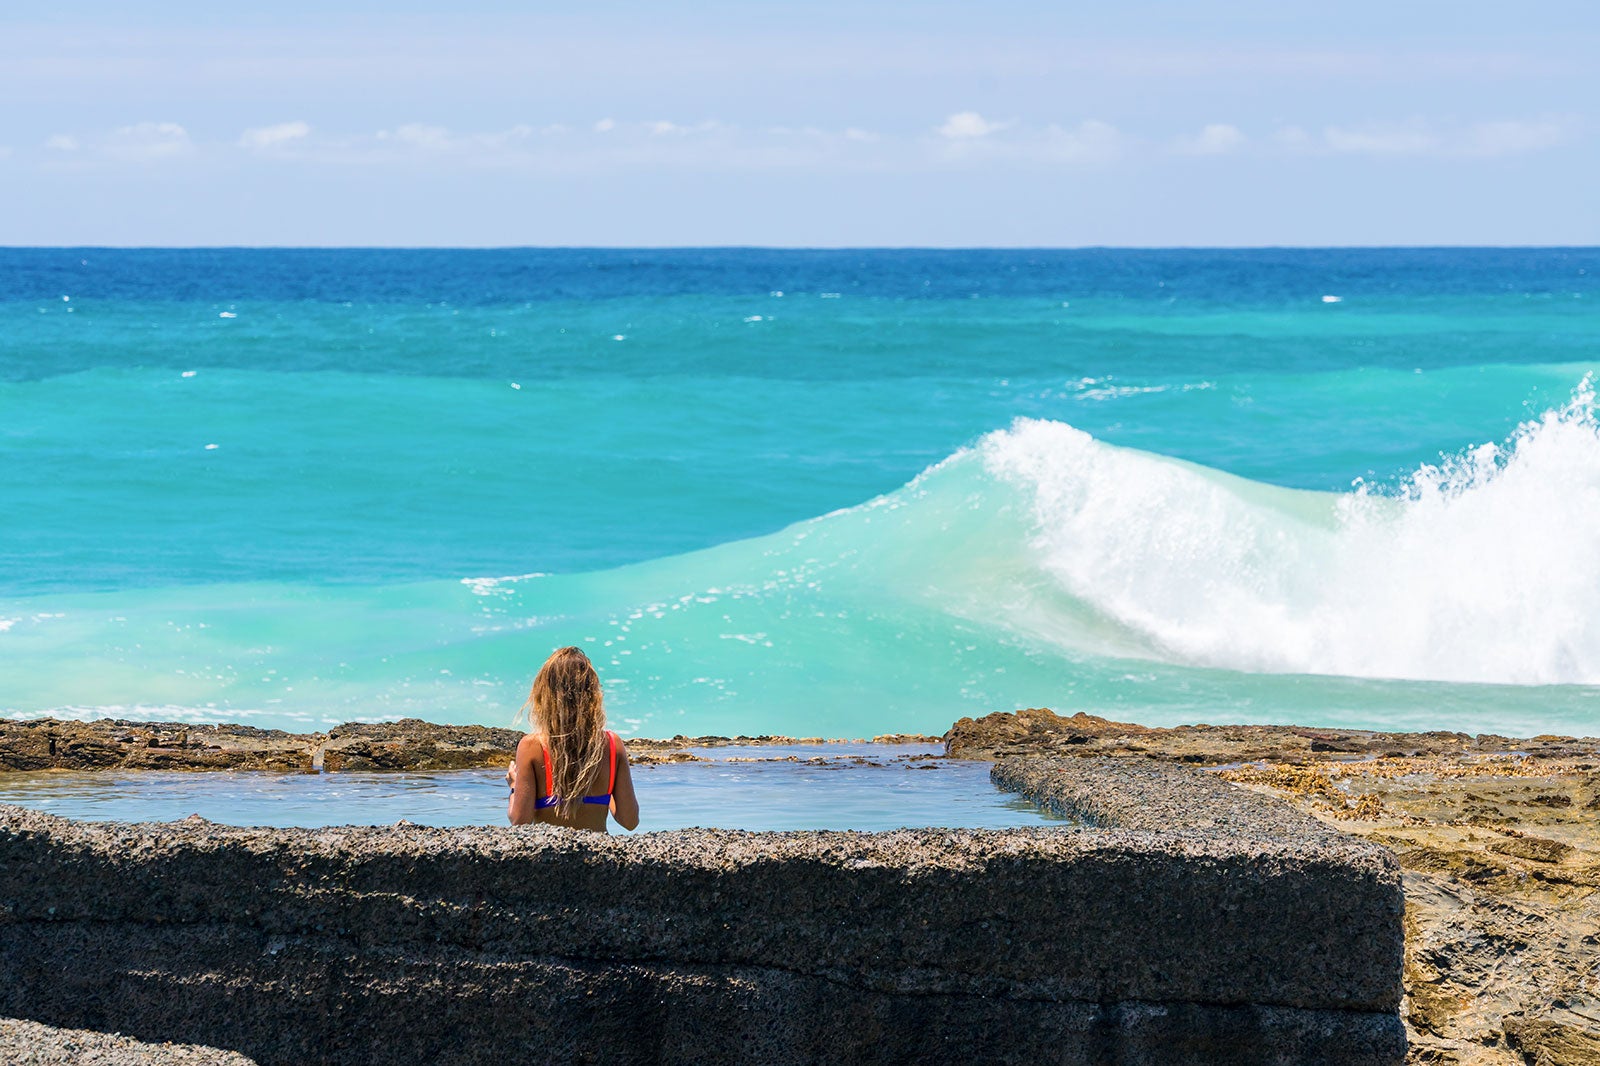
[966, 709, 1600, 1066]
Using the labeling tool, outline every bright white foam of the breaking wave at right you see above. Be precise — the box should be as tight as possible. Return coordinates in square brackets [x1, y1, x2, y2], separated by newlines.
[979, 381, 1600, 685]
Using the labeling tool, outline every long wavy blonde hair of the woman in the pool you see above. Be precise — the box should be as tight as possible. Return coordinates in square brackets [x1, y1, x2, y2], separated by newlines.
[522, 647, 610, 818]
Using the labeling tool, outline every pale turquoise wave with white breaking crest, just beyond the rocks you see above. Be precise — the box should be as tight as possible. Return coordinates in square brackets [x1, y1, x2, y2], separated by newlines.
[0, 379, 1600, 736]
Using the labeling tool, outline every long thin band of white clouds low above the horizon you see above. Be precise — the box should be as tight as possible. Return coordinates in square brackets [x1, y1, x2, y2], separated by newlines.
[43, 110, 1581, 173]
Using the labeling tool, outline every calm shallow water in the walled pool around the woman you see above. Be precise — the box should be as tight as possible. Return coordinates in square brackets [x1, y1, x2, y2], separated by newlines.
[0, 744, 1062, 832]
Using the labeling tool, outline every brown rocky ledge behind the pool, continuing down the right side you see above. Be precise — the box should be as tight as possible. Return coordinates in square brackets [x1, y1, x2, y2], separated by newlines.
[0, 709, 1600, 1066]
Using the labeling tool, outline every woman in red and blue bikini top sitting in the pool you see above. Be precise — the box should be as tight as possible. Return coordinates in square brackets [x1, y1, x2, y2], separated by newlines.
[506, 648, 638, 832]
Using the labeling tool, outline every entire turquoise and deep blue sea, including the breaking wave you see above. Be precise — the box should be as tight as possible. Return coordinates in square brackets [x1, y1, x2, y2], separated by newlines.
[0, 250, 1600, 736]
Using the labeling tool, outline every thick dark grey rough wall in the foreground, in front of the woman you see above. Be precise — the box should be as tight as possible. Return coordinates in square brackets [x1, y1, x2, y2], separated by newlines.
[0, 760, 1405, 1066]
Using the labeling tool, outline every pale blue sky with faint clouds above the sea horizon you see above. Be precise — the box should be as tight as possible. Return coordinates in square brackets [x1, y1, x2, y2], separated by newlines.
[0, 0, 1600, 246]
